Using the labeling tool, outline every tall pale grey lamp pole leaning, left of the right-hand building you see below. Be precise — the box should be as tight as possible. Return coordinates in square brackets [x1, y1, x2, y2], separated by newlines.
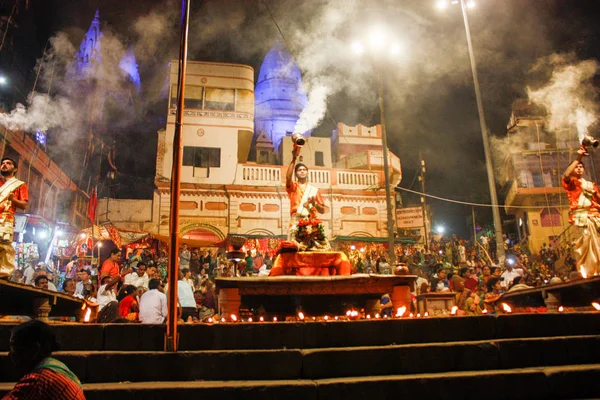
[460, 0, 504, 264]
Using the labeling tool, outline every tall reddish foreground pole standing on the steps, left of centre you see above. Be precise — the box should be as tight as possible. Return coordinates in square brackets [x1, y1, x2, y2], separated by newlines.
[165, 0, 190, 351]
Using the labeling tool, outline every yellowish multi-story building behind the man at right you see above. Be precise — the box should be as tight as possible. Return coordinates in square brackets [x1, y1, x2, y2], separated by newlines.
[501, 99, 600, 253]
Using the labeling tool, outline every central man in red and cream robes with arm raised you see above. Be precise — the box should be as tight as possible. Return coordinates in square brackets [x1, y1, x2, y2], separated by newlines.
[285, 144, 331, 251]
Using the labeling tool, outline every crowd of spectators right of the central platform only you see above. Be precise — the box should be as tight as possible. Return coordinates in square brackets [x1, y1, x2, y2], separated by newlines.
[340, 235, 582, 315]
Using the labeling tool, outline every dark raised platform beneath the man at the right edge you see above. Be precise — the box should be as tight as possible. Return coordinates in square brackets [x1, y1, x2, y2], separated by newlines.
[496, 276, 600, 311]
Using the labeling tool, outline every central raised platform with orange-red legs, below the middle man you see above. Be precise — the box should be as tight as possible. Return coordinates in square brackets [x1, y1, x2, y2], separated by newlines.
[216, 274, 417, 315]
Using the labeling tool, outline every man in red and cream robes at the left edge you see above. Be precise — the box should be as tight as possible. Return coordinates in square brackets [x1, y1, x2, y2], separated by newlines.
[0, 157, 29, 279]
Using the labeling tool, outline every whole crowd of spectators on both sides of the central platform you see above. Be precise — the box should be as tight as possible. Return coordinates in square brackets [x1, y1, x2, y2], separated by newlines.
[3, 225, 581, 323]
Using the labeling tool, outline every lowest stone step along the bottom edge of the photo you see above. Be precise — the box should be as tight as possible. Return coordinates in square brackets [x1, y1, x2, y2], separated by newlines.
[0, 364, 600, 400]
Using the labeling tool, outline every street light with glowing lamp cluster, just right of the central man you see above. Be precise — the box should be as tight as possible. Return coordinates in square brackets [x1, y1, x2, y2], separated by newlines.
[352, 28, 400, 265]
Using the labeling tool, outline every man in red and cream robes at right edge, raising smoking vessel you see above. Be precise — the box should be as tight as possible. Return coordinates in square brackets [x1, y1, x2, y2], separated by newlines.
[562, 146, 600, 276]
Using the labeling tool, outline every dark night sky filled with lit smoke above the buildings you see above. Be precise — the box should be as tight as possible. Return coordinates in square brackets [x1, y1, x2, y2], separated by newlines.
[0, 0, 600, 237]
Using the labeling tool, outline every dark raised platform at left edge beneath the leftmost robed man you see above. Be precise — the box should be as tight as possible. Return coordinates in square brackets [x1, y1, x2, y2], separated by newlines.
[0, 280, 87, 320]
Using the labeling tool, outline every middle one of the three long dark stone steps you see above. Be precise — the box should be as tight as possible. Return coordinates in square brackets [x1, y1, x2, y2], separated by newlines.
[0, 335, 600, 383]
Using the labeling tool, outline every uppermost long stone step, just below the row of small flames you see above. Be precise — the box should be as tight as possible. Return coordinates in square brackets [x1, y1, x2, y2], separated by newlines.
[0, 312, 600, 351]
